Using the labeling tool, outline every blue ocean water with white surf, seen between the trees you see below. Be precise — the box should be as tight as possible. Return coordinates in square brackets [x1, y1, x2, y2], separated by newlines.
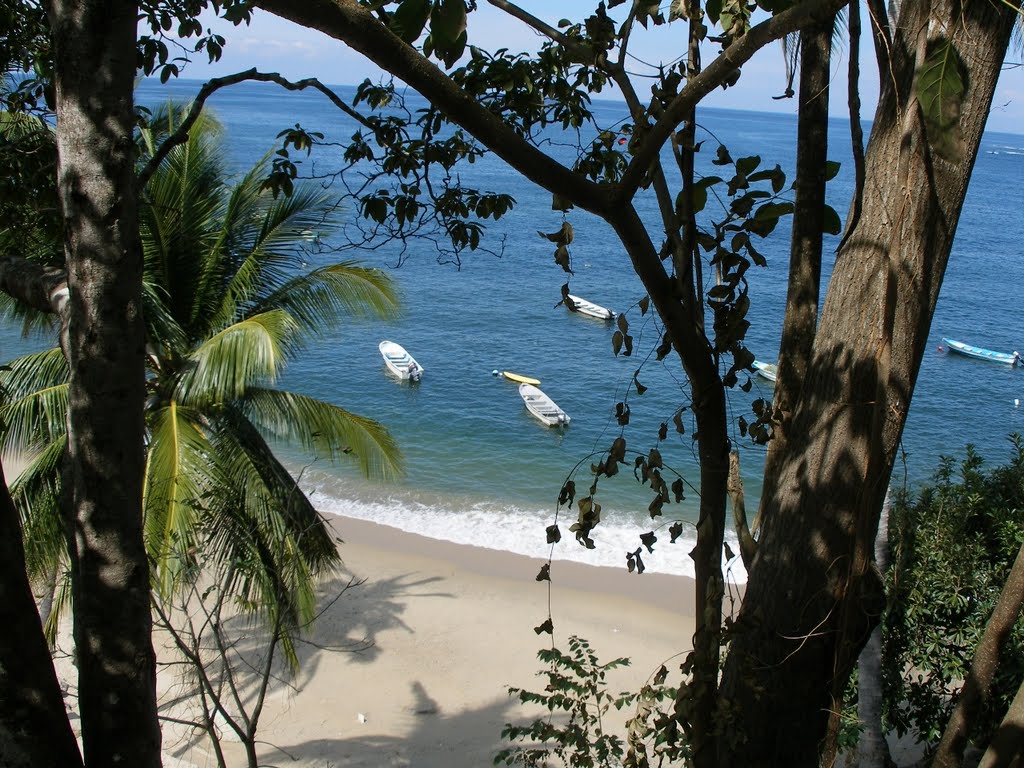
[0, 81, 1024, 580]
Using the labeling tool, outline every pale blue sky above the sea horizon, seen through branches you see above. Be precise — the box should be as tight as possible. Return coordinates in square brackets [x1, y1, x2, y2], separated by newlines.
[182, 0, 1024, 133]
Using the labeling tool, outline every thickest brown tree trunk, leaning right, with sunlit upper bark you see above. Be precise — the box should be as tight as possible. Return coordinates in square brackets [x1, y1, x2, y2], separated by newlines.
[722, 0, 1014, 768]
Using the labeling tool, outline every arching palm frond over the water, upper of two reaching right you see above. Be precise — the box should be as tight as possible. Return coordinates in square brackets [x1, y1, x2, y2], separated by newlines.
[257, 261, 398, 335]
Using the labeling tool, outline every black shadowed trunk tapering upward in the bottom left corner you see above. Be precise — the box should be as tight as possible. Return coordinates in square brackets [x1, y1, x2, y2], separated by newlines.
[0, 460, 82, 768]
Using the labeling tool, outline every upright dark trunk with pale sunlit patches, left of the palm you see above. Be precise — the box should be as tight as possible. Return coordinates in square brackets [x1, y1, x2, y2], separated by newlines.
[49, 0, 160, 768]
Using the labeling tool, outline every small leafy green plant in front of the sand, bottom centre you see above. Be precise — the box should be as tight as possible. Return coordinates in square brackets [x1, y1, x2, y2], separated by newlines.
[494, 635, 667, 768]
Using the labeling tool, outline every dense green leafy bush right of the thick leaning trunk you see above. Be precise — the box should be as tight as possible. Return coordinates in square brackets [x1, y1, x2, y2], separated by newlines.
[883, 435, 1024, 744]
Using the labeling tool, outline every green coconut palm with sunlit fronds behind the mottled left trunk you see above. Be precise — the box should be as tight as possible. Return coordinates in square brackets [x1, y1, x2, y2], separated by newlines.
[0, 100, 399, 648]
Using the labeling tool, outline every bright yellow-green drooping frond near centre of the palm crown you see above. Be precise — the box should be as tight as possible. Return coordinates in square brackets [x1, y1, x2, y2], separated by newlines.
[176, 310, 297, 406]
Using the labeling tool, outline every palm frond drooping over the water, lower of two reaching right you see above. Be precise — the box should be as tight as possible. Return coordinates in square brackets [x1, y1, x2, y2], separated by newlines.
[243, 388, 401, 479]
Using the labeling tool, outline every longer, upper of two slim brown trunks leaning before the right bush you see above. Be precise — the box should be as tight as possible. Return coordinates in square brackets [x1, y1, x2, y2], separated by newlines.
[932, 546, 1024, 768]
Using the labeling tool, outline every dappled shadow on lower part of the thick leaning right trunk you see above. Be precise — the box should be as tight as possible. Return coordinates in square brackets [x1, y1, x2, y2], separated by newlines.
[723, 221, 941, 765]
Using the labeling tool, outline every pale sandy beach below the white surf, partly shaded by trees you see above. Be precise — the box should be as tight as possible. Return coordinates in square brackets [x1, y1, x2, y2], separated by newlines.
[165, 518, 693, 768]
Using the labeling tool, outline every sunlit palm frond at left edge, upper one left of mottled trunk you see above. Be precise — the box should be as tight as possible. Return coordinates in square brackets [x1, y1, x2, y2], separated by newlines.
[0, 348, 68, 453]
